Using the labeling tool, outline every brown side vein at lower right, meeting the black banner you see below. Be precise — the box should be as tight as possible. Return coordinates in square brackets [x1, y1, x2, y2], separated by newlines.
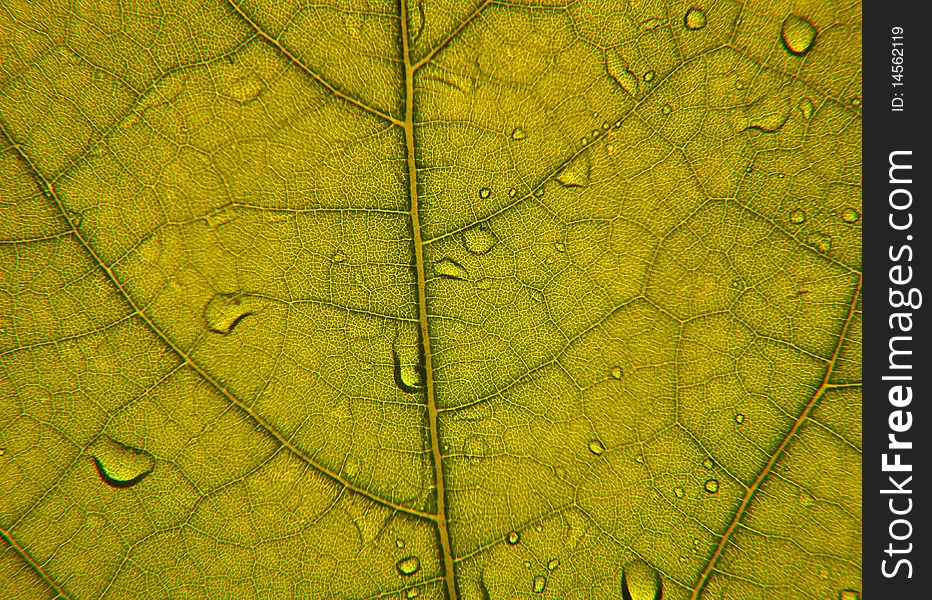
[689, 277, 863, 600]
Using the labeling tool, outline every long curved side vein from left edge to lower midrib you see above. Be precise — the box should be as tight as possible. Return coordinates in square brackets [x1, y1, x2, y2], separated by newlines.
[0, 123, 437, 521]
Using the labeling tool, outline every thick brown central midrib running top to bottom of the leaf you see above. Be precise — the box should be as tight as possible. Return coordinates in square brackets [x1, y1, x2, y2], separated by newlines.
[400, 0, 458, 600]
